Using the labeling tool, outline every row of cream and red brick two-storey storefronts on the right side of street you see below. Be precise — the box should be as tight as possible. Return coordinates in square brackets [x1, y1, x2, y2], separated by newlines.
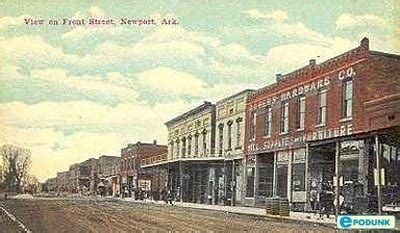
[142, 38, 400, 212]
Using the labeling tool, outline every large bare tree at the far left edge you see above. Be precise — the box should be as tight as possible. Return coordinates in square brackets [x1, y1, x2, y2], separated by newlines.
[0, 145, 31, 193]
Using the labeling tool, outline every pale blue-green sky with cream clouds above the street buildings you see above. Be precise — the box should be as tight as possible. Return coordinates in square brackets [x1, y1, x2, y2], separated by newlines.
[0, 0, 400, 181]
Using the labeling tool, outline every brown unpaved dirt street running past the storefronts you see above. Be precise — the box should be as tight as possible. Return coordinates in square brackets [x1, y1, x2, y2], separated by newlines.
[0, 199, 335, 233]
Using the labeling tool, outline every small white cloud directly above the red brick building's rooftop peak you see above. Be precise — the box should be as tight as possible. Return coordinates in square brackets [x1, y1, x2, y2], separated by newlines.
[336, 14, 389, 30]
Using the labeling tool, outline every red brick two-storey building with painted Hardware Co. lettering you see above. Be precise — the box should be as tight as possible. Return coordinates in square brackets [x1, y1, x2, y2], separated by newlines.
[245, 38, 400, 211]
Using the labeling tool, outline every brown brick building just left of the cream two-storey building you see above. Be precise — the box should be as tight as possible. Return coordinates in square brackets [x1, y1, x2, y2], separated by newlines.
[120, 140, 168, 198]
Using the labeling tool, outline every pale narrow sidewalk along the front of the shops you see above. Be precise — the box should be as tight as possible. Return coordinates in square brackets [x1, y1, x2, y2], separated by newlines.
[121, 198, 336, 226]
